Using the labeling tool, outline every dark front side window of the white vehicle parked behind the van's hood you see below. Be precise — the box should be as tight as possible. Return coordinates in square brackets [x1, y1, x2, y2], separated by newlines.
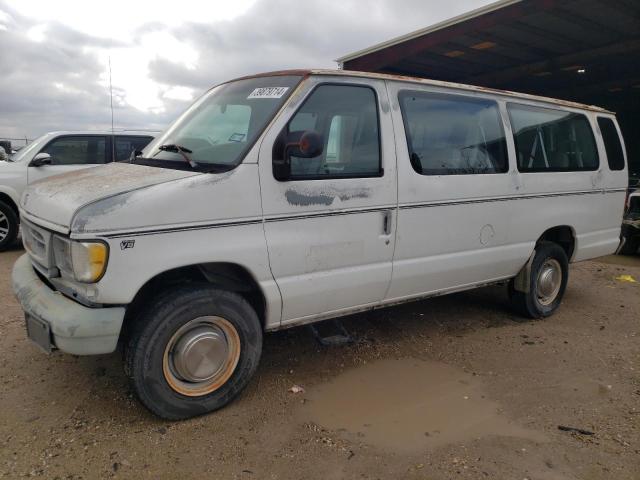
[41, 135, 107, 165]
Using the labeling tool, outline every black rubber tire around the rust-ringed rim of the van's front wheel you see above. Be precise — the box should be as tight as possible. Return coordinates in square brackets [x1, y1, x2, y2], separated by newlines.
[125, 284, 262, 420]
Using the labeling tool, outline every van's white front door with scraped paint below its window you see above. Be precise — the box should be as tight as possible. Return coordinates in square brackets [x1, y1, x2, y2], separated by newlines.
[259, 77, 397, 324]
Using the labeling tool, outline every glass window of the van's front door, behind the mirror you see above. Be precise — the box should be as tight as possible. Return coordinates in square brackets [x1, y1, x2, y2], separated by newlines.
[287, 85, 382, 180]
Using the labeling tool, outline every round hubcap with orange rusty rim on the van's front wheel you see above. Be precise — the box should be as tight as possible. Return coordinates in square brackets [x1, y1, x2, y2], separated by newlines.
[163, 316, 240, 396]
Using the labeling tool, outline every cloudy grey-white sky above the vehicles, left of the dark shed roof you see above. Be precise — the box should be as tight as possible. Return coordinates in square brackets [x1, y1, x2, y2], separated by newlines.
[0, 0, 491, 143]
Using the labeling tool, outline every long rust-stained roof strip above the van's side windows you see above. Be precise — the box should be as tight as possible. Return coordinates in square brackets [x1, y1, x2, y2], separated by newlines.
[236, 69, 614, 115]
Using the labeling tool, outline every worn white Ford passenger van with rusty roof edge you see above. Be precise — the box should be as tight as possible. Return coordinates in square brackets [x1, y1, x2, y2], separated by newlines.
[13, 71, 627, 419]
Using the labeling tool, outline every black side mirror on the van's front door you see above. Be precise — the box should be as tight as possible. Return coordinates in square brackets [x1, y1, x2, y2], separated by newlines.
[273, 130, 324, 182]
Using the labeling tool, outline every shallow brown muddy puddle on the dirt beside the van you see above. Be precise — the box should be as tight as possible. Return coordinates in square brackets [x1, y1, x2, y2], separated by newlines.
[297, 358, 545, 453]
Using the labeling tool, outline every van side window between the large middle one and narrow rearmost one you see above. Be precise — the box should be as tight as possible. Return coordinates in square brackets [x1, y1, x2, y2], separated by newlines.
[507, 104, 599, 172]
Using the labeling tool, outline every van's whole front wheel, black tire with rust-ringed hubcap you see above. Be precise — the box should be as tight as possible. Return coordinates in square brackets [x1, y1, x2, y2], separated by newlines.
[125, 285, 262, 420]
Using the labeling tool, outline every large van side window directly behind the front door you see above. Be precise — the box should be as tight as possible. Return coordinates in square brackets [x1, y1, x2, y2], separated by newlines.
[399, 91, 509, 175]
